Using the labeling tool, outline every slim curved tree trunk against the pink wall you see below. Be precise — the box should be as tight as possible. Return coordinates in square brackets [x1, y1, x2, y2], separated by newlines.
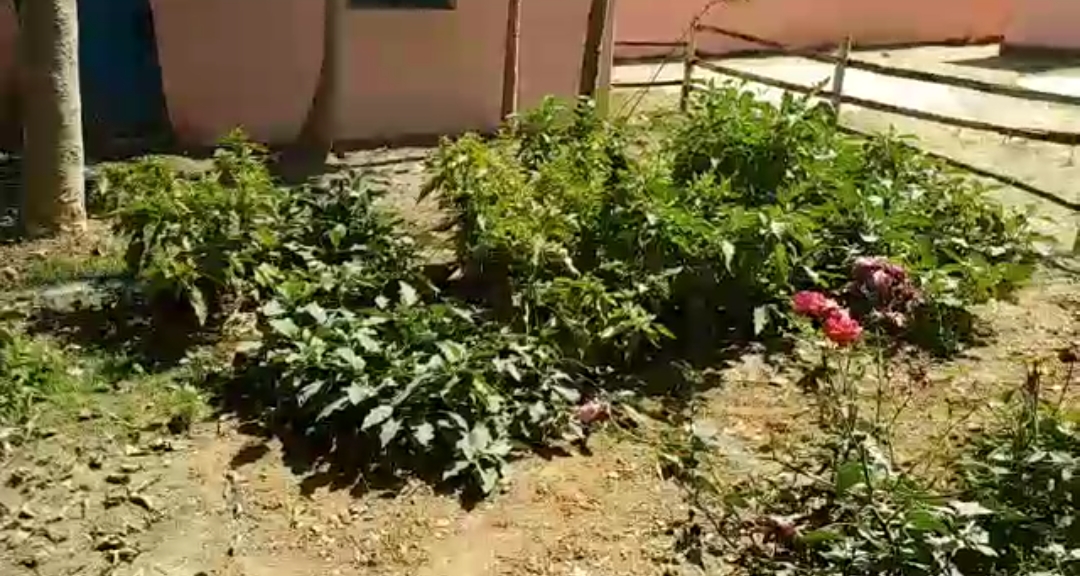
[297, 0, 348, 162]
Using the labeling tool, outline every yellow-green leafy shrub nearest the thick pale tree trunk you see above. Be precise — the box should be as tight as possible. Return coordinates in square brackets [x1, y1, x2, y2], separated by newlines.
[114, 132, 282, 324]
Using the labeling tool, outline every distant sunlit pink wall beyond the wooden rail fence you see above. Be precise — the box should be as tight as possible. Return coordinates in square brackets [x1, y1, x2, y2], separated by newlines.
[616, 0, 1010, 58]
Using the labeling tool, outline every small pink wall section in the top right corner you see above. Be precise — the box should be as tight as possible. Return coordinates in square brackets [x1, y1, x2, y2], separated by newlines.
[1004, 0, 1080, 50]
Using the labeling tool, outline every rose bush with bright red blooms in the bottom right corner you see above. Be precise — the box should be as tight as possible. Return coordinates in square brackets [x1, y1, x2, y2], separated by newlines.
[661, 293, 1080, 576]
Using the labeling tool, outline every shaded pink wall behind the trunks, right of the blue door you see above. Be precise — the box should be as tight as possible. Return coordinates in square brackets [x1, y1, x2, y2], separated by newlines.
[152, 0, 589, 144]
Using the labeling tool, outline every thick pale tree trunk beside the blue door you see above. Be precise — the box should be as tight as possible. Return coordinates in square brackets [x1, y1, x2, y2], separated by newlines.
[19, 0, 86, 237]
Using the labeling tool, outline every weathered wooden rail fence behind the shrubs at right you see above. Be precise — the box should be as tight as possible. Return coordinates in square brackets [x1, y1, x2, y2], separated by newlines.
[612, 19, 1080, 254]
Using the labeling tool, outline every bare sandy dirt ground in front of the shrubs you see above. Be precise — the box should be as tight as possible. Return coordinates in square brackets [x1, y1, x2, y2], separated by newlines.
[0, 263, 1080, 576]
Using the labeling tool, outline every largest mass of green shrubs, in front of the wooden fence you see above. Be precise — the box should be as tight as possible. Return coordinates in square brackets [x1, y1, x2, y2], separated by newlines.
[429, 88, 1037, 362]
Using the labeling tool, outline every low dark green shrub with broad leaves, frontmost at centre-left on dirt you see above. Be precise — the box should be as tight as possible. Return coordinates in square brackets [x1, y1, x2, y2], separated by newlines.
[254, 284, 578, 494]
